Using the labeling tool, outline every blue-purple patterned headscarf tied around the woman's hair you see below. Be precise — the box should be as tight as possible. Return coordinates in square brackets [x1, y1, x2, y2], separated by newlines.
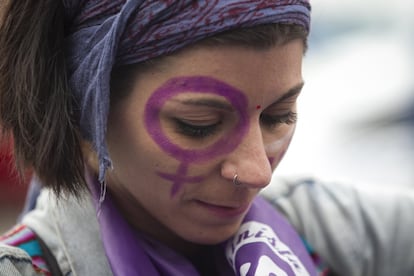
[63, 0, 310, 182]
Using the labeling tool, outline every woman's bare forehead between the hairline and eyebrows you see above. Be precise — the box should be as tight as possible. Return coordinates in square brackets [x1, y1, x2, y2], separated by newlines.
[129, 40, 303, 104]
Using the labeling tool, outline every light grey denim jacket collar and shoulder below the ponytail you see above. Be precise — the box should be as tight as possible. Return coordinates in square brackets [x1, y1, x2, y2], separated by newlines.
[0, 190, 112, 276]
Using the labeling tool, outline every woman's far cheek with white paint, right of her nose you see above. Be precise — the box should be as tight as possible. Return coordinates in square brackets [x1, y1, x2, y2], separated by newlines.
[265, 126, 295, 169]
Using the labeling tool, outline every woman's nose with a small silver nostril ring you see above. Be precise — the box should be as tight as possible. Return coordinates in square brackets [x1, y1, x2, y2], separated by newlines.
[221, 126, 272, 189]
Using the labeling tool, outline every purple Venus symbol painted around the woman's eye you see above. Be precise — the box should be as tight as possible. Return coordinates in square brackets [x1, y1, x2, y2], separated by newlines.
[144, 76, 249, 196]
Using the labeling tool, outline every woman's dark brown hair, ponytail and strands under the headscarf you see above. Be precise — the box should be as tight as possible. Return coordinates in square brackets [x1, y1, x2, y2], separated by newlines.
[0, 0, 307, 198]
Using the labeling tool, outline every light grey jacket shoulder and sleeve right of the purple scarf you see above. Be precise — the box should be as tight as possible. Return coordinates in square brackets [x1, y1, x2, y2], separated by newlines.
[266, 179, 414, 276]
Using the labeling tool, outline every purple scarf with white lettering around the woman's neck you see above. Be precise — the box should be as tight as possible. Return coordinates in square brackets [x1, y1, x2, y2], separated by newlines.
[87, 171, 317, 276]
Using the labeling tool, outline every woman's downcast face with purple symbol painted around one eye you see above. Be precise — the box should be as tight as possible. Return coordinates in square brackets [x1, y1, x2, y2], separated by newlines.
[107, 40, 303, 249]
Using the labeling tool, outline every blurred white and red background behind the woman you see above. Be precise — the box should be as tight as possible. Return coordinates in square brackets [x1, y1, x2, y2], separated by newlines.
[0, 0, 414, 232]
